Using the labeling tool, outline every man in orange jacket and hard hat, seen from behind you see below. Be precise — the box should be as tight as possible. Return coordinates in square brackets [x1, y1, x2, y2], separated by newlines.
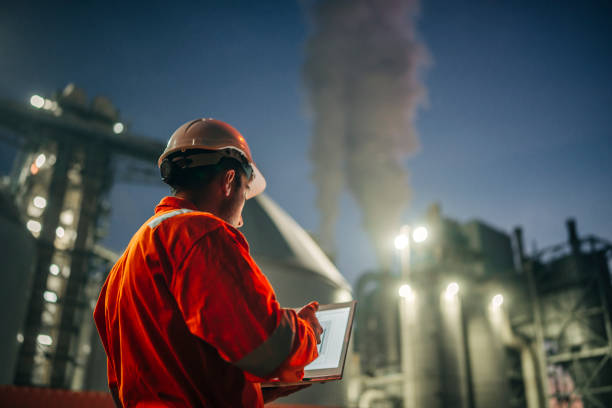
[94, 119, 322, 408]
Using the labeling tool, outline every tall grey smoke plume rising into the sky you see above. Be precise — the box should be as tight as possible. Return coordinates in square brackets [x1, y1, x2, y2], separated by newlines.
[303, 0, 427, 267]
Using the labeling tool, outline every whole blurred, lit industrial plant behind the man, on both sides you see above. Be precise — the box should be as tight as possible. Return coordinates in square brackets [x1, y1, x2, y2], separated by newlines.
[0, 84, 612, 408]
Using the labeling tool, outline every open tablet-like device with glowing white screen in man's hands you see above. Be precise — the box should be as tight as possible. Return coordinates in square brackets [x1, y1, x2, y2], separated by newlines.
[261, 300, 357, 388]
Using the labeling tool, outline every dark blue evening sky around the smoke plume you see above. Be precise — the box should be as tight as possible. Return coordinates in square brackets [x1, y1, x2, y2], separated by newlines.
[0, 0, 612, 283]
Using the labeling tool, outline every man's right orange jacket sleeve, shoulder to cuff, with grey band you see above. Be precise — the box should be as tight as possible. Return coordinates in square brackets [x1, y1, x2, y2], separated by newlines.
[169, 225, 317, 381]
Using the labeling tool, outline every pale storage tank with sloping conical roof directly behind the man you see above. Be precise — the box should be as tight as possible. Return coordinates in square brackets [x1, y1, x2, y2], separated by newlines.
[86, 194, 353, 406]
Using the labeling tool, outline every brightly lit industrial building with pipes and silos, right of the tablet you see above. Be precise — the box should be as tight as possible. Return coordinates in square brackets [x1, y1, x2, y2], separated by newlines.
[355, 205, 612, 408]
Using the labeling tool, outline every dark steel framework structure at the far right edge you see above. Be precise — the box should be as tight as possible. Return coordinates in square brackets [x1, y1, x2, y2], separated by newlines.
[524, 220, 612, 408]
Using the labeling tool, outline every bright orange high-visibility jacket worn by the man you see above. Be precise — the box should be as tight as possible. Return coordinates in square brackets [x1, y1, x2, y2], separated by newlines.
[94, 197, 317, 408]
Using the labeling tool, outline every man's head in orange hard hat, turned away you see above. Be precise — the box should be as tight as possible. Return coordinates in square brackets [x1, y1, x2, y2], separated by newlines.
[158, 119, 266, 227]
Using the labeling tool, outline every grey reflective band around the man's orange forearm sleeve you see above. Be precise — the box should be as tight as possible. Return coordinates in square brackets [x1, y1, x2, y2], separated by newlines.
[234, 310, 295, 377]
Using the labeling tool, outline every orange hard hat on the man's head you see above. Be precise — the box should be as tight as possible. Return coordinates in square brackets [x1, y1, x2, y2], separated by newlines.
[157, 118, 266, 199]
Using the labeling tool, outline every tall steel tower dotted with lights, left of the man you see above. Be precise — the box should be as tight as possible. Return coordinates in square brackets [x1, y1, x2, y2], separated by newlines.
[0, 85, 164, 389]
